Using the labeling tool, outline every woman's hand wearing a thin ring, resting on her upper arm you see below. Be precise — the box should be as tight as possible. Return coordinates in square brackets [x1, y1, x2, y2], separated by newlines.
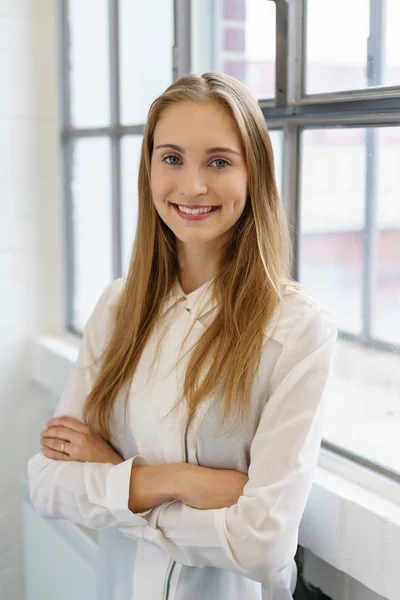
[40, 417, 124, 465]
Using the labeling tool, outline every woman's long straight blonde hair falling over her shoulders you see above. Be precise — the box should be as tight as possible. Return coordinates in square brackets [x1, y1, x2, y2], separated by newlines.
[83, 73, 296, 439]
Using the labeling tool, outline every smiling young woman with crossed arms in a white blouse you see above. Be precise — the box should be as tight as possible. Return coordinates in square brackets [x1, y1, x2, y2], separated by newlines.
[28, 73, 337, 600]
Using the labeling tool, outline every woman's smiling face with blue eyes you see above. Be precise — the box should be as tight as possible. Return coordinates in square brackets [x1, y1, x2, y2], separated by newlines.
[151, 102, 247, 243]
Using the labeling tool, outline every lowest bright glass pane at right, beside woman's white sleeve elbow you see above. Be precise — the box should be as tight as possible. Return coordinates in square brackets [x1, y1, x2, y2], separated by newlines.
[323, 338, 400, 473]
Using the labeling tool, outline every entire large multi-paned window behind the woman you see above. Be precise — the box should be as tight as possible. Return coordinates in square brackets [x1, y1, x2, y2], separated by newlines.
[59, 0, 400, 481]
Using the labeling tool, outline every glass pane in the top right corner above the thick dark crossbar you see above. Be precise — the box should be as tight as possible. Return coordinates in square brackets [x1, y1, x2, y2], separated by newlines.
[305, 0, 400, 94]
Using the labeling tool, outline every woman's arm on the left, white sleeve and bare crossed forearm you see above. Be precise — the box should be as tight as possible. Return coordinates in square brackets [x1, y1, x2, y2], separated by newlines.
[28, 281, 247, 537]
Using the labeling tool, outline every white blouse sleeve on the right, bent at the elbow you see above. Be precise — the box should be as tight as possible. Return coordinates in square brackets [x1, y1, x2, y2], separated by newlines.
[116, 308, 337, 583]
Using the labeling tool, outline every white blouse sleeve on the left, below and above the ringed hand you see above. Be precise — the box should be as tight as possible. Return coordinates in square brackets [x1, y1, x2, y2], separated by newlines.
[28, 278, 150, 537]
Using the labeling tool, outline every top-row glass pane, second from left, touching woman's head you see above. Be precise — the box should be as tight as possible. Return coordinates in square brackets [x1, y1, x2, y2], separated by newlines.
[119, 0, 174, 124]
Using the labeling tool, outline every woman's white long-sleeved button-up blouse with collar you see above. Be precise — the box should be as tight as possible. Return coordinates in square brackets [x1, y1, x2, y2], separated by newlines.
[28, 278, 337, 600]
